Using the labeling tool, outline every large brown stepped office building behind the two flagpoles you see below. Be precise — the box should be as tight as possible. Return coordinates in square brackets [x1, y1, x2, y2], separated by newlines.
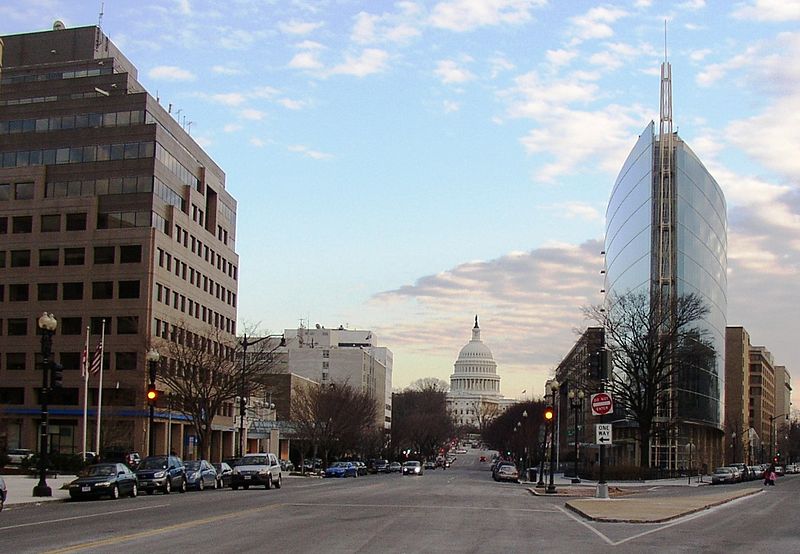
[0, 23, 239, 458]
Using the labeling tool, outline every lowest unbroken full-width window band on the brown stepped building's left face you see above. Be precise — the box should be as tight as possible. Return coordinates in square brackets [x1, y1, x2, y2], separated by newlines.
[0, 141, 155, 167]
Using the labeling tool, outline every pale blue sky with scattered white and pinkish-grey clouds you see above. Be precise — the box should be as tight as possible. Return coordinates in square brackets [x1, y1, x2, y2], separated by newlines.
[0, 0, 800, 405]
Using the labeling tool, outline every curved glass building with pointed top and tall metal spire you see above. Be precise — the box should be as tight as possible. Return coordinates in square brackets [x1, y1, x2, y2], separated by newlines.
[605, 122, 727, 468]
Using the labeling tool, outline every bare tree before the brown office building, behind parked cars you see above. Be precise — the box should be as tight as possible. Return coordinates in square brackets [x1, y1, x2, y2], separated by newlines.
[158, 324, 277, 458]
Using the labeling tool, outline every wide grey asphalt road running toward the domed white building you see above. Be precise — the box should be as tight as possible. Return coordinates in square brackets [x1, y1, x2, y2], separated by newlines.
[0, 451, 800, 554]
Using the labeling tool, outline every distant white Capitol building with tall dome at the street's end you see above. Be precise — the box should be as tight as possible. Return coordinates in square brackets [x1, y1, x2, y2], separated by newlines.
[447, 316, 516, 430]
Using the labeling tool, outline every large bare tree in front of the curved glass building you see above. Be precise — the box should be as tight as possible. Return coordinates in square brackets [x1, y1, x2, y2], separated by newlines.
[584, 292, 716, 467]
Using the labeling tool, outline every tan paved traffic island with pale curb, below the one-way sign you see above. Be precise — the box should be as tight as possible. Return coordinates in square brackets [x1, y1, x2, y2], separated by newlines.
[566, 488, 762, 523]
